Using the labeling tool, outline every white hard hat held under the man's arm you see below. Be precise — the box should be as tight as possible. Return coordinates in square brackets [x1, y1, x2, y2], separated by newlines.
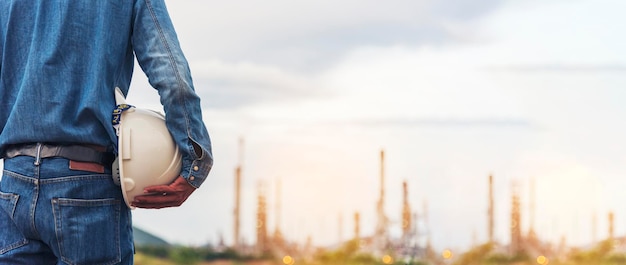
[113, 88, 182, 209]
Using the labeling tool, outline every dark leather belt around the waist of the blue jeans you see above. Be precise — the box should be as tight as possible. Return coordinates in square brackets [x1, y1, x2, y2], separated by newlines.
[5, 143, 115, 166]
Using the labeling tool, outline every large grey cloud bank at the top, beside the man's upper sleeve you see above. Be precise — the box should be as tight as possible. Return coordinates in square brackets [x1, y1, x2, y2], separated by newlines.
[160, 0, 503, 110]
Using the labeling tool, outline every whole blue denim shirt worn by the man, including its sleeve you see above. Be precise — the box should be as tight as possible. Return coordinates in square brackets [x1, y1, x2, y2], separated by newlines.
[0, 0, 213, 187]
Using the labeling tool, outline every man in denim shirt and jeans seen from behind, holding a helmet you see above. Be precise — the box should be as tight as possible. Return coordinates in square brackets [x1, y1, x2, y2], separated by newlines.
[0, 0, 213, 265]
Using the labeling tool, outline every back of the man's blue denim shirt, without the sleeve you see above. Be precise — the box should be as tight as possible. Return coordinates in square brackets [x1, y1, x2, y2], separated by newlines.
[0, 0, 134, 152]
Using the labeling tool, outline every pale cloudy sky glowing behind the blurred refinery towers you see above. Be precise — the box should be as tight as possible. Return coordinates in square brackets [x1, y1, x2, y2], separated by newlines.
[3, 0, 626, 253]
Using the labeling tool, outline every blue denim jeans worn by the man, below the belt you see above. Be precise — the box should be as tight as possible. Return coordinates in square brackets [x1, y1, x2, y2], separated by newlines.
[0, 156, 134, 265]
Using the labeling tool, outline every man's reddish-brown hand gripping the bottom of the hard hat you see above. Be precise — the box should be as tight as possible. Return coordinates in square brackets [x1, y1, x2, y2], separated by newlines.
[130, 176, 196, 209]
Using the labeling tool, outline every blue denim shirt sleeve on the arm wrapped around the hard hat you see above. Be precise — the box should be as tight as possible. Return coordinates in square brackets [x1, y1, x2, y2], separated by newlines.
[131, 0, 213, 188]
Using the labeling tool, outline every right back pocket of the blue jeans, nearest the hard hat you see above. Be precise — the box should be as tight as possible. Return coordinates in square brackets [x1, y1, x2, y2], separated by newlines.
[52, 198, 121, 265]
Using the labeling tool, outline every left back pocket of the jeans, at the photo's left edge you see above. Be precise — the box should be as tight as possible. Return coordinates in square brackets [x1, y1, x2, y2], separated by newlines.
[0, 192, 28, 254]
